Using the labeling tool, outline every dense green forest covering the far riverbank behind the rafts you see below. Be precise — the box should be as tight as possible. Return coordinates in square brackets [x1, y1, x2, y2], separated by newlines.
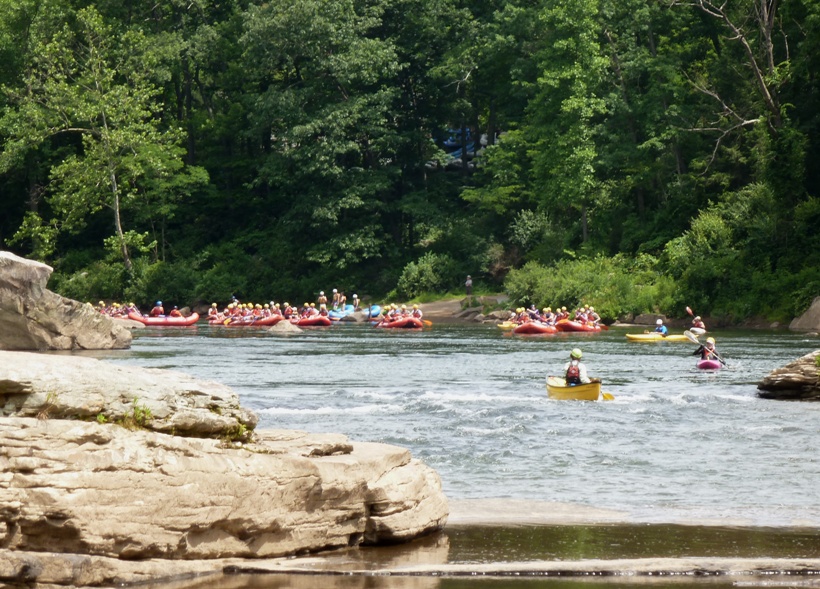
[0, 0, 820, 323]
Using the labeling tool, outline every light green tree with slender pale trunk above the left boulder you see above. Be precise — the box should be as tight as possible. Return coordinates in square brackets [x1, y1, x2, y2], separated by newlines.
[0, 8, 206, 273]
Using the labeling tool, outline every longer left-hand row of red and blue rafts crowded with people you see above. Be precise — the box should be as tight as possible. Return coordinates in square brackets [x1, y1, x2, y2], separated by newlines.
[128, 301, 430, 329]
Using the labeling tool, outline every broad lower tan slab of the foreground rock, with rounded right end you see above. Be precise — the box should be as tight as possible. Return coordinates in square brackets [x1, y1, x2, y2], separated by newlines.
[0, 418, 448, 569]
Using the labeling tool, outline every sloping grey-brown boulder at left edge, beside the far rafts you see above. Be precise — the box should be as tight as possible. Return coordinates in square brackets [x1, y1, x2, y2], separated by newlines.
[0, 252, 131, 350]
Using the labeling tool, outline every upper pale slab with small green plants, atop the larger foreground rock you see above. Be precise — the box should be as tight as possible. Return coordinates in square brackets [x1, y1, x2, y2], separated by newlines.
[0, 351, 258, 439]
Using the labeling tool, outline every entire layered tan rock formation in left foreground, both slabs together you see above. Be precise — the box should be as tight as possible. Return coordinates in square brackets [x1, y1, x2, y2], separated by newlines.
[0, 352, 448, 586]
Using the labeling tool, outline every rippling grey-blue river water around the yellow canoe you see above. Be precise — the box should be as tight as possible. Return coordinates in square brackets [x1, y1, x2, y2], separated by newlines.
[97, 324, 820, 528]
